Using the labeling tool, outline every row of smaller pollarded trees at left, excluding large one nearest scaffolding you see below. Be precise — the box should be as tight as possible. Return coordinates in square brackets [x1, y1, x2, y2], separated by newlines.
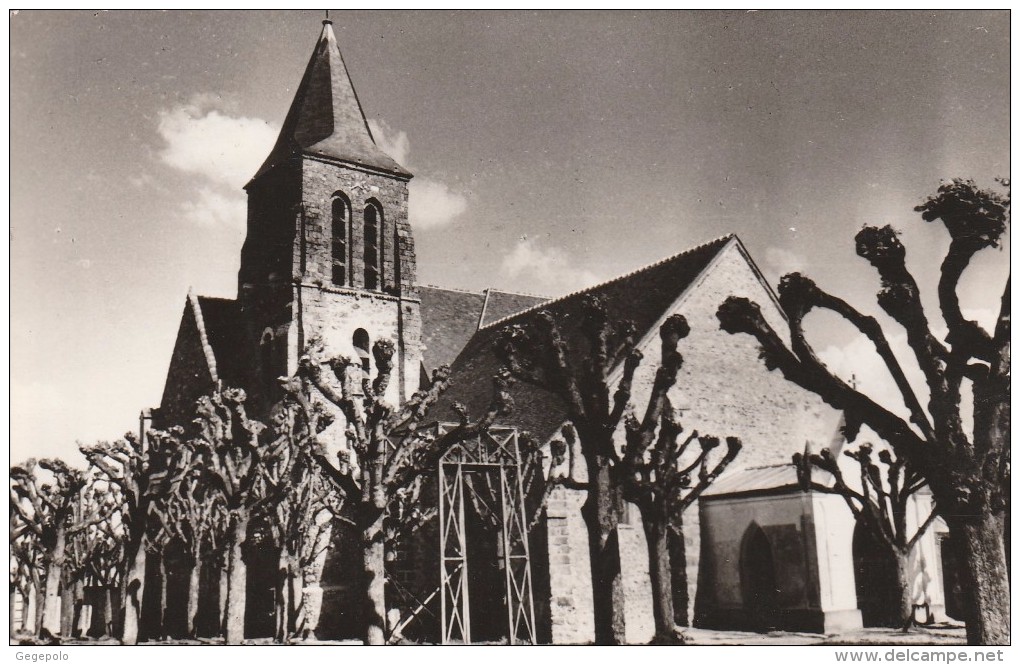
[10, 391, 343, 644]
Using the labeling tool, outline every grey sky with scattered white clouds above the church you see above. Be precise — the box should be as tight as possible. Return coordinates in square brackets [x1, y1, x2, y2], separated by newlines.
[9, 10, 1010, 461]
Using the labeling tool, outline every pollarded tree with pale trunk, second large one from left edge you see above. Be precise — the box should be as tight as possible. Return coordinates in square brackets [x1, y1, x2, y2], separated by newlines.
[80, 429, 181, 645]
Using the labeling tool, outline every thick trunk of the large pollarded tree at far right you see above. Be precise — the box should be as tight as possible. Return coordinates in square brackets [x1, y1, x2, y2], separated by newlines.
[946, 513, 1010, 646]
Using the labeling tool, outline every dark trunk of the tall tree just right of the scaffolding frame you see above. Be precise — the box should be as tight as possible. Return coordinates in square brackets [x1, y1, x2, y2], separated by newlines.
[581, 461, 626, 645]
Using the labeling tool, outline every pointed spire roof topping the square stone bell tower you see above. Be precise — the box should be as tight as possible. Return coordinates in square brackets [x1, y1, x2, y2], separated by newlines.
[255, 17, 411, 177]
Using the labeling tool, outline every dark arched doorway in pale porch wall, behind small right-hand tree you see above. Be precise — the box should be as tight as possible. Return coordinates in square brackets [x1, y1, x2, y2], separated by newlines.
[854, 522, 903, 628]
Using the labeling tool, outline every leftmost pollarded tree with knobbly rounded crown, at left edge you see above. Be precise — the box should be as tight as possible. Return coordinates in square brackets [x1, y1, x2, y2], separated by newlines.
[10, 459, 86, 635]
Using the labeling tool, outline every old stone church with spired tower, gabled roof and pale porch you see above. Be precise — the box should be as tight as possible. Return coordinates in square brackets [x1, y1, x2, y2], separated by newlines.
[153, 20, 947, 644]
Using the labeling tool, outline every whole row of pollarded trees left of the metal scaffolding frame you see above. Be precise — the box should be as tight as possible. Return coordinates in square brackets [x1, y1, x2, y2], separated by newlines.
[10, 341, 509, 644]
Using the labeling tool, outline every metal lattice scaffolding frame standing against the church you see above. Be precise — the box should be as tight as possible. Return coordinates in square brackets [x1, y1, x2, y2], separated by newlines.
[438, 423, 536, 645]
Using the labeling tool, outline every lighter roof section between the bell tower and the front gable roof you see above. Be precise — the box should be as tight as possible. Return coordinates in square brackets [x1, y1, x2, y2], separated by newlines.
[418, 287, 548, 371]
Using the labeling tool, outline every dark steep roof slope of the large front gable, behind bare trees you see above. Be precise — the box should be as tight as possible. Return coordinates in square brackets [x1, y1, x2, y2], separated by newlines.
[431, 235, 738, 440]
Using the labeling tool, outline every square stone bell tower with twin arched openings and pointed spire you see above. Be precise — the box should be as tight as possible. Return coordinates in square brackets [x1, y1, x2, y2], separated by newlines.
[238, 19, 421, 404]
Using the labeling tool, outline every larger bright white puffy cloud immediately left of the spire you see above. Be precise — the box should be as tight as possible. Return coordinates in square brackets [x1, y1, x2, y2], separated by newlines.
[158, 96, 279, 189]
